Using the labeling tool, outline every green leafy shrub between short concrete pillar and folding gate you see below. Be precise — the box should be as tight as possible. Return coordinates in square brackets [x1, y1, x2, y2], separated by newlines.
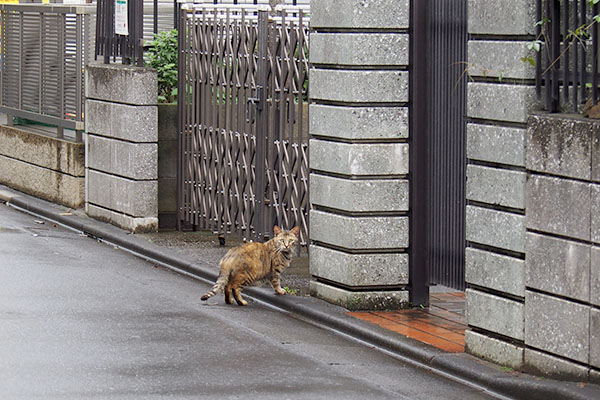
[145, 29, 178, 103]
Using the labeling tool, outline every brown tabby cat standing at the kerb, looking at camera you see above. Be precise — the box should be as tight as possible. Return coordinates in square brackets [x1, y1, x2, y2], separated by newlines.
[200, 226, 300, 306]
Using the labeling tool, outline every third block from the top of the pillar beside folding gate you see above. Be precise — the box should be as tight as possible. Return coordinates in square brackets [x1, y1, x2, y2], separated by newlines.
[309, 69, 408, 103]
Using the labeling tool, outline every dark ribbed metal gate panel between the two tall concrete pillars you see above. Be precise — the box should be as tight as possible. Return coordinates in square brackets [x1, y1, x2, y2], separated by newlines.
[410, 0, 468, 296]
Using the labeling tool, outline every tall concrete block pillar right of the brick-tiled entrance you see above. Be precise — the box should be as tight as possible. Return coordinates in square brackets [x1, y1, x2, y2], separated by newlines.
[465, 0, 537, 368]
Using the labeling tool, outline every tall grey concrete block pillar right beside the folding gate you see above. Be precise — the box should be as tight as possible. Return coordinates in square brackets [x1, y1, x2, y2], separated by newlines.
[309, 0, 410, 310]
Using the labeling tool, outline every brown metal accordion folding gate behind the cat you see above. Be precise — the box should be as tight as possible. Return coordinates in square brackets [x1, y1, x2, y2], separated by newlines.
[178, 4, 310, 244]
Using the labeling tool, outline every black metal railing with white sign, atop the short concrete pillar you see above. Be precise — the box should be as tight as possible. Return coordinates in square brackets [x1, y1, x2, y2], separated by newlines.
[95, 0, 144, 66]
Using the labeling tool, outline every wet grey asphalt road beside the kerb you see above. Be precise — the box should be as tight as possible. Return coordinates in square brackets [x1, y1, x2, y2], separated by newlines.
[0, 204, 490, 400]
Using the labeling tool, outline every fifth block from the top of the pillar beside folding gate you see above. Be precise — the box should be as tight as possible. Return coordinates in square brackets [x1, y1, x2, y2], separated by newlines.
[309, 139, 408, 176]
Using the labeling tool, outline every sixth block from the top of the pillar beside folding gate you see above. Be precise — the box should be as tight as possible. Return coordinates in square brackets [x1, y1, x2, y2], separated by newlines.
[310, 174, 409, 212]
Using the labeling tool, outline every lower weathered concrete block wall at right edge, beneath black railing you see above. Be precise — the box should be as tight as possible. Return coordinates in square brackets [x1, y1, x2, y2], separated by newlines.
[524, 114, 600, 380]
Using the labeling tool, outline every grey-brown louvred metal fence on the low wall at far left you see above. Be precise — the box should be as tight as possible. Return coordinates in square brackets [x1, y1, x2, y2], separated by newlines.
[0, 4, 95, 141]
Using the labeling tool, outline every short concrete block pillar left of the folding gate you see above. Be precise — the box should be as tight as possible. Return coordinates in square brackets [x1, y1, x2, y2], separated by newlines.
[85, 64, 158, 232]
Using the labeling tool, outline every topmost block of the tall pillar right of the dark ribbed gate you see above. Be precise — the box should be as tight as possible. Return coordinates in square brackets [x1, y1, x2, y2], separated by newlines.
[468, 0, 536, 35]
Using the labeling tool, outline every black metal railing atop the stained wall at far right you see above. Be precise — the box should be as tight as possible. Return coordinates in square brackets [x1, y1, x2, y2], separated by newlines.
[534, 0, 600, 112]
